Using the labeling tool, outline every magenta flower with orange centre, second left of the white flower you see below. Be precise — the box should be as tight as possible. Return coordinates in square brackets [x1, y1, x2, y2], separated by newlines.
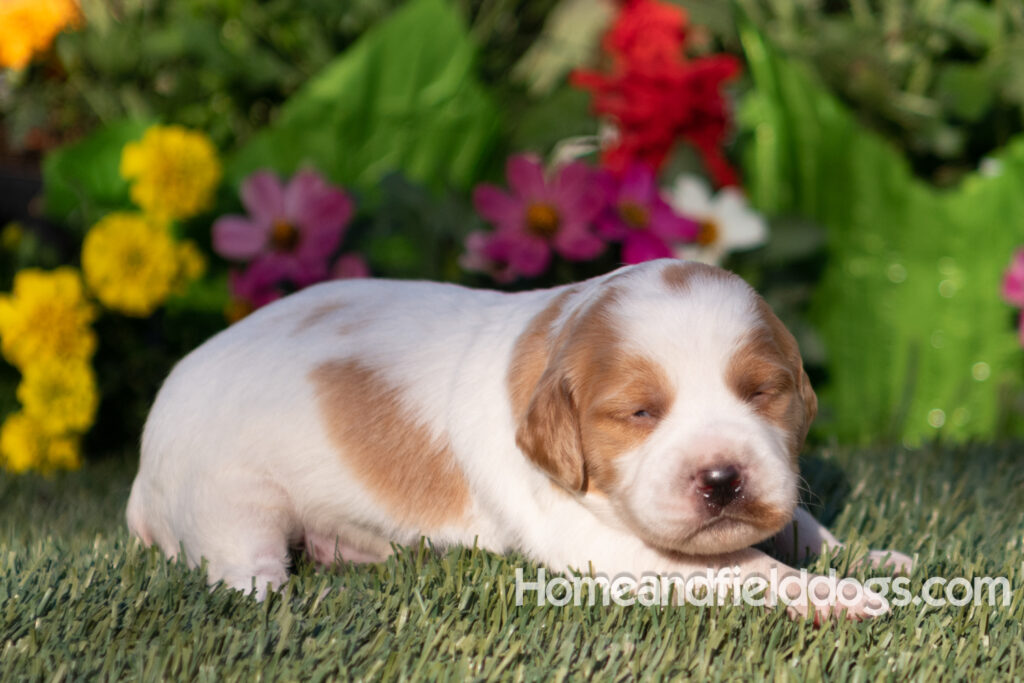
[467, 155, 604, 278]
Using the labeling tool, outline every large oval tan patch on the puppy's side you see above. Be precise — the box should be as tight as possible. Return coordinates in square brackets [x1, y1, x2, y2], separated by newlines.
[310, 360, 470, 531]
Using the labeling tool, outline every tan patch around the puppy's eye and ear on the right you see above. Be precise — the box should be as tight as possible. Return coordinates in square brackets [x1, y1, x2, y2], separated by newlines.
[726, 297, 818, 466]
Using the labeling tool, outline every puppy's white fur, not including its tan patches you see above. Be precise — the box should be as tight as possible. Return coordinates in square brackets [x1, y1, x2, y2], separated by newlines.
[127, 260, 913, 618]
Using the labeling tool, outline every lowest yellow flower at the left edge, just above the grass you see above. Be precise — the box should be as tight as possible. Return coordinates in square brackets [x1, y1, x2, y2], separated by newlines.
[0, 413, 81, 474]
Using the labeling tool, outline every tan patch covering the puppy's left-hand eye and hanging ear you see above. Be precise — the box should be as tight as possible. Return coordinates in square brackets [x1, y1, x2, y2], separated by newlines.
[509, 287, 672, 494]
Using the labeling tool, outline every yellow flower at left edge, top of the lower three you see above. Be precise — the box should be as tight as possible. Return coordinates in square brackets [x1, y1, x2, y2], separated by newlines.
[0, 266, 96, 370]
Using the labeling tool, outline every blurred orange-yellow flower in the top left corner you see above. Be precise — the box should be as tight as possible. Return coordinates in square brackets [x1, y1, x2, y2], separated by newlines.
[0, 0, 81, 69]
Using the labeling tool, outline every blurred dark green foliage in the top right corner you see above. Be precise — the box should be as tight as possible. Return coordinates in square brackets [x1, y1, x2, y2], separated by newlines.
[739, 0, 1024, 186]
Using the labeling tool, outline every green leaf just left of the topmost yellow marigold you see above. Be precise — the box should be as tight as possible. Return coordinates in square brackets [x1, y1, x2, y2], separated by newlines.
[43, 116, 151, 224]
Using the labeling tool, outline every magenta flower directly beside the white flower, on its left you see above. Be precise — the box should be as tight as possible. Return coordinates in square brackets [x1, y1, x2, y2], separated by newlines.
[597, 164, 700, 263]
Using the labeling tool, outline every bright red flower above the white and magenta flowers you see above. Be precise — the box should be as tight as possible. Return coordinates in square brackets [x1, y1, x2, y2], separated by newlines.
[572, 0, 739, 185]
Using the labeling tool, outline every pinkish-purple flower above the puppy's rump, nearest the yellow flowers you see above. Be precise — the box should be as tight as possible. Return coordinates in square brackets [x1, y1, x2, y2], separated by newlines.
[213, 170, 352, 287]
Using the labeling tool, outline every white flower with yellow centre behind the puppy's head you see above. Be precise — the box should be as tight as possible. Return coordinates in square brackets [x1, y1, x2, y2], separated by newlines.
[669, 175, 768, 265]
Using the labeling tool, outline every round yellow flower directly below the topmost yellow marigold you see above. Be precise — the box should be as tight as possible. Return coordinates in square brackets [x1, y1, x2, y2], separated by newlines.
[82, 212, 189, 317]
